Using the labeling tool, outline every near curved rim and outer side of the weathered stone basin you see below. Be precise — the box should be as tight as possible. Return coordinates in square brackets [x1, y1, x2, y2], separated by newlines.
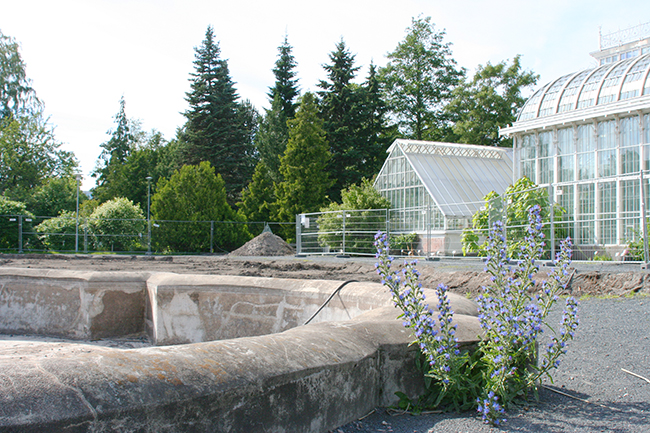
[0, 308, 479, 432]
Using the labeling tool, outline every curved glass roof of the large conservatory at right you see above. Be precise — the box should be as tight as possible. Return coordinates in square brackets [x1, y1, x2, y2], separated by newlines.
[517, 54, 650, 122]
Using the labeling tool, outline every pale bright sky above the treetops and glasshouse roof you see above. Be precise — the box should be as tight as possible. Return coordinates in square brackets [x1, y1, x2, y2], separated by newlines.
[0, 0, 650, 190]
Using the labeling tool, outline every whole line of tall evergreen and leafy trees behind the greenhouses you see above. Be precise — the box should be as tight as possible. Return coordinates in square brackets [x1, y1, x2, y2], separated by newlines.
[0, 17, 538, 251]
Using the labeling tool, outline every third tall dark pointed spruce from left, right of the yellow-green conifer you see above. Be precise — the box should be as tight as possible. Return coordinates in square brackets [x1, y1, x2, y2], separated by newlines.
[318, 40, 362, 200]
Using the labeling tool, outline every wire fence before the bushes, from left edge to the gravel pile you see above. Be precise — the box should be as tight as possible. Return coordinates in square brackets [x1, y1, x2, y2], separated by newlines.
[0, 215, 295, 254]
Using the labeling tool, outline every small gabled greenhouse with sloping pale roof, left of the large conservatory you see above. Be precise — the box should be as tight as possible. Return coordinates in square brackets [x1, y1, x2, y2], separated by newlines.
[375, 139, 513, 255]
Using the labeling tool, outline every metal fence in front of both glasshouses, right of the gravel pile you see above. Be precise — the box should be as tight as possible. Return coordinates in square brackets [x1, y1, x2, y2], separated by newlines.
[296, 182, 648, 262]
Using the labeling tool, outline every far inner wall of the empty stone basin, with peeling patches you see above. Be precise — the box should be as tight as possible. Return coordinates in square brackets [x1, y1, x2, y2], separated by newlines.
[0, 268, 476, 345]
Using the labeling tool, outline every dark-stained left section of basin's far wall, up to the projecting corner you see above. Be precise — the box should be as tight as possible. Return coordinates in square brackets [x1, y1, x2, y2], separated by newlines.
[0, 268, 149, 339]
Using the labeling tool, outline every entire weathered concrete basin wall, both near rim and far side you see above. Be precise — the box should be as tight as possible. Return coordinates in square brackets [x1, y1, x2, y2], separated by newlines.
[0, 268, 480, 433]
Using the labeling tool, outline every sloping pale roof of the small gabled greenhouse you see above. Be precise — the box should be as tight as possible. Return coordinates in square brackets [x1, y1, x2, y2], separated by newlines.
[388, 140, 513, 218]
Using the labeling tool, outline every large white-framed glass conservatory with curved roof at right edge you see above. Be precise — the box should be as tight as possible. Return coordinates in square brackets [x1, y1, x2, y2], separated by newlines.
[500, 33, 650, 258]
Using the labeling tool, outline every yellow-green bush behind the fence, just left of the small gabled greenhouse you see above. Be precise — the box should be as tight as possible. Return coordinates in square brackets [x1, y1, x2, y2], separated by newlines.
[318, 178, 391, 253]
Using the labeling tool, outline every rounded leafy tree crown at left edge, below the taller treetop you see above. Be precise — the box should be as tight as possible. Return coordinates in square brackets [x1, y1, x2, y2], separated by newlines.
[0, 112, 77, 201]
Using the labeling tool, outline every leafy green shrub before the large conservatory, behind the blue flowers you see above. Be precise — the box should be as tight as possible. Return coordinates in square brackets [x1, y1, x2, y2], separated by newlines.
[461, 177, 565, 256]
